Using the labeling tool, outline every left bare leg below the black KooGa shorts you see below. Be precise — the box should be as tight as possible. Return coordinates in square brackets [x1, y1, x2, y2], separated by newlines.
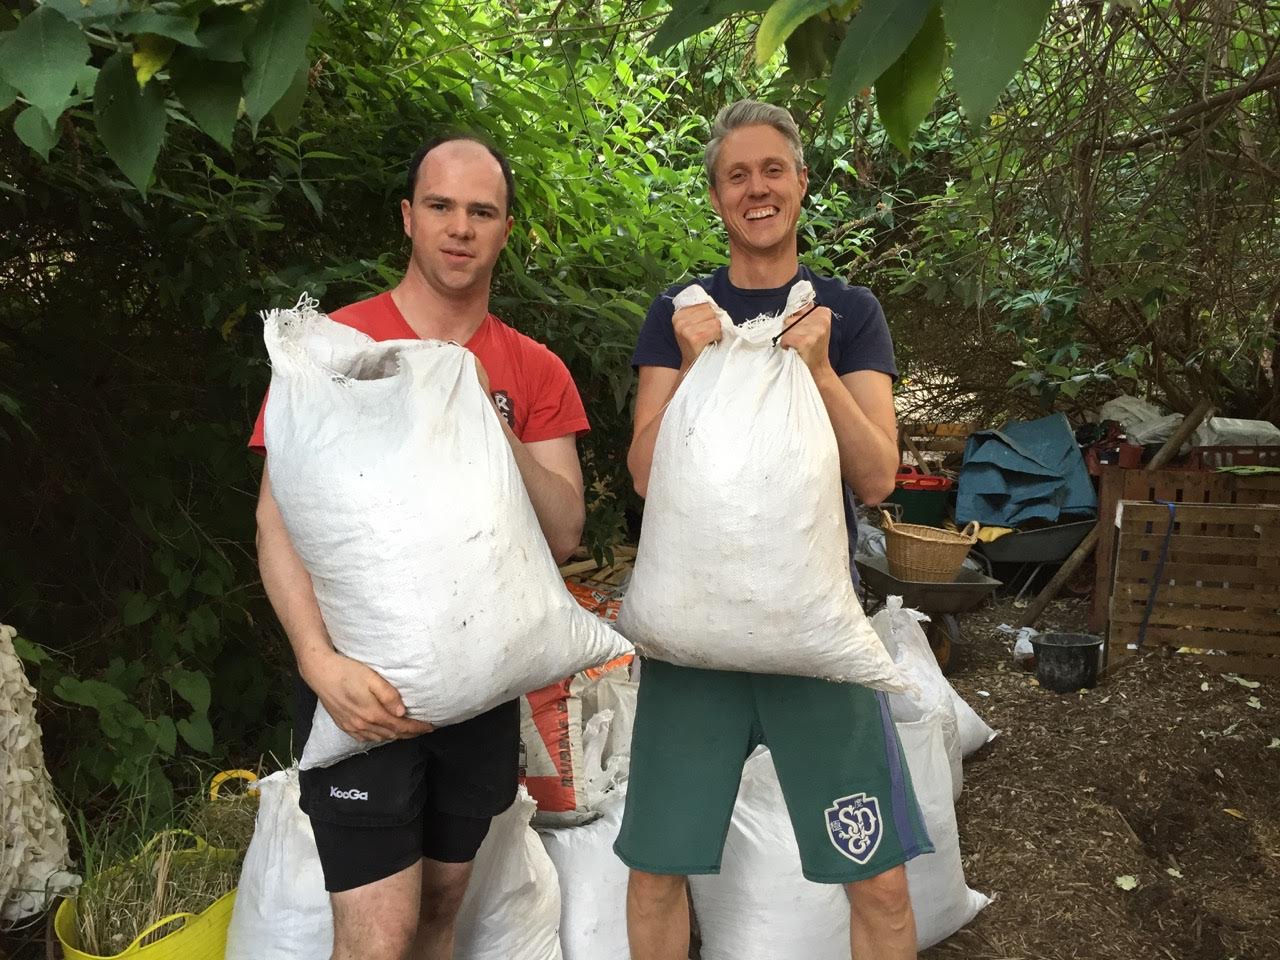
[329, 860, 422, 960]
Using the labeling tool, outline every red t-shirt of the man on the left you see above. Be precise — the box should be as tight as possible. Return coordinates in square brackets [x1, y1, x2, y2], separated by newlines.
[248, 293, 590, 454]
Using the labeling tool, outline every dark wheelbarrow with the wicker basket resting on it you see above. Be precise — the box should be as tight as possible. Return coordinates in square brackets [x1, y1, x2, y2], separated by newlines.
[854, 557, 1002, 673]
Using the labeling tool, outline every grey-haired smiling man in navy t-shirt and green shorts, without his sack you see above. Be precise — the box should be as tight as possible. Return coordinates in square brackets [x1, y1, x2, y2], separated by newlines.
[614, 100, 933, 960]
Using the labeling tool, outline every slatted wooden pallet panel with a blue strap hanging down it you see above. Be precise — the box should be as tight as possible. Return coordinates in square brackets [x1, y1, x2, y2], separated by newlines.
[1107, 500, 1280, 676]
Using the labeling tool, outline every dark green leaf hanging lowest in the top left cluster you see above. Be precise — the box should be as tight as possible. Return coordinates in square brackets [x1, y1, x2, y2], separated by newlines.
[93, 54, 166, 196]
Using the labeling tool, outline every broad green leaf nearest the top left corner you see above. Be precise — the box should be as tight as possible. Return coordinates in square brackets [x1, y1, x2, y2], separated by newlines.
[0, 6, 90, 127]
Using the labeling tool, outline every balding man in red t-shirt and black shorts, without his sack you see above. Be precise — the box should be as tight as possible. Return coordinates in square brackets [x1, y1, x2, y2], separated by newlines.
[250, 136, 588, 960]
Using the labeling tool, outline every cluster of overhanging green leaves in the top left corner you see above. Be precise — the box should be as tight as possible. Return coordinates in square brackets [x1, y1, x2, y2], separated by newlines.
[0, 0, 315, 195]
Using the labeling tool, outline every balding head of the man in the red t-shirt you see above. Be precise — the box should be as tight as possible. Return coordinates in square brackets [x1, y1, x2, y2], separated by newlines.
[401, 140, 512, 296]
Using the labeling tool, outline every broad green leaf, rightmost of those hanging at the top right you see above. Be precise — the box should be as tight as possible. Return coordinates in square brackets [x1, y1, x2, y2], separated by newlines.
[942, 0, 1053, 123]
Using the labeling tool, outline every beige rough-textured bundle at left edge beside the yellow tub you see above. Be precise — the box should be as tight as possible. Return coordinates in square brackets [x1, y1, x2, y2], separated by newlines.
[0, 623, 79, 922]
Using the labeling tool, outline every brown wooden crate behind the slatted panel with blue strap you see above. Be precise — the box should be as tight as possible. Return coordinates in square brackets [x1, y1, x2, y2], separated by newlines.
[1089, 466, 1280, 634]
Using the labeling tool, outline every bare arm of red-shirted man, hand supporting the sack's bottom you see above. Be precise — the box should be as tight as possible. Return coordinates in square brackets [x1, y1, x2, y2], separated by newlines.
[257, 468, 431, 740]
